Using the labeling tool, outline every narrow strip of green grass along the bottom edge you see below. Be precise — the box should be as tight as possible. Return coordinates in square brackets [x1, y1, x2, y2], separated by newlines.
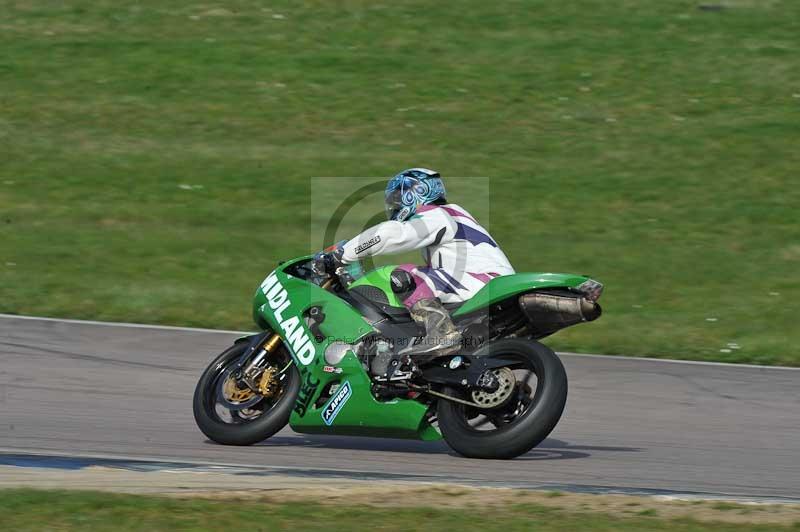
[0, 490, 791, 532]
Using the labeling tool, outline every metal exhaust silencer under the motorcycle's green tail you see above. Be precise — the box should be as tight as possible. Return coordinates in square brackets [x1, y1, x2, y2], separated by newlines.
[519, 292, 602, 333]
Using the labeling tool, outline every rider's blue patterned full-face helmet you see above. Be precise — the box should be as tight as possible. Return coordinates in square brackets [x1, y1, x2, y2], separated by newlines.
[386, 168, 445, 222]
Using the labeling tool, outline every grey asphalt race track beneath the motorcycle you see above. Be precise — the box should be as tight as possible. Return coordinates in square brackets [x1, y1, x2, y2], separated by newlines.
[0, 317, 800, 500]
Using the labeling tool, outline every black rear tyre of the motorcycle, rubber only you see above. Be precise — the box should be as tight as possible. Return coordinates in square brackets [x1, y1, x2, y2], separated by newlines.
[437, 338, 567, 459]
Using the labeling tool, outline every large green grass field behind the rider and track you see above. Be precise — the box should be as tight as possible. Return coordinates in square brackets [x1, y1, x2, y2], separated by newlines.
[0, 0, 800, 365]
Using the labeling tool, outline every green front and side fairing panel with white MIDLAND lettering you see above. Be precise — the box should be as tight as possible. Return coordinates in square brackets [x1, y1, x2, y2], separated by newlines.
[253, 257, 441, 440]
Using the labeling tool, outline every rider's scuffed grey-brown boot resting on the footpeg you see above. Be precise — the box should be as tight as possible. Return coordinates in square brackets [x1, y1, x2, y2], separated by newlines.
[370, 298, 461, 379]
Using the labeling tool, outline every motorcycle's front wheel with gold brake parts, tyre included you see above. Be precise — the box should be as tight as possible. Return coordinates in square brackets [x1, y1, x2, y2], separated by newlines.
[193, 342, 300, 445]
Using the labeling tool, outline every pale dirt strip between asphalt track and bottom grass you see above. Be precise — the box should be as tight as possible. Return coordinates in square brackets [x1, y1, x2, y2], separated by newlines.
[0, 466, 800, 525]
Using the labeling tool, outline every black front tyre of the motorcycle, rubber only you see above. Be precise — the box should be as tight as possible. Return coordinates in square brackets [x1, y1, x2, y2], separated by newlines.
[193, 342, 300, 445]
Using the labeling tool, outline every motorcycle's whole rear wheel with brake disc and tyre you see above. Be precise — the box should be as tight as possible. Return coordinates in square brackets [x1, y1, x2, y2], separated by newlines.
[437, 338, 567, 459]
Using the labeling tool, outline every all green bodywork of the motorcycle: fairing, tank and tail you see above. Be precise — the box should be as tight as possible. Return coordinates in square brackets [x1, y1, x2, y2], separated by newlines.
[253, 256, 589, 440]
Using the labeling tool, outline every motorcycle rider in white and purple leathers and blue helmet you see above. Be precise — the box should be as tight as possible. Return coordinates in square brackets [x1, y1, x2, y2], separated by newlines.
[319, 168, 514, 376]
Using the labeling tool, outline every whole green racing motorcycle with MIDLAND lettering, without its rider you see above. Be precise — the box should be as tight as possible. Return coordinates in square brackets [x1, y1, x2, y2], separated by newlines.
[193, 256, 603, 458]
